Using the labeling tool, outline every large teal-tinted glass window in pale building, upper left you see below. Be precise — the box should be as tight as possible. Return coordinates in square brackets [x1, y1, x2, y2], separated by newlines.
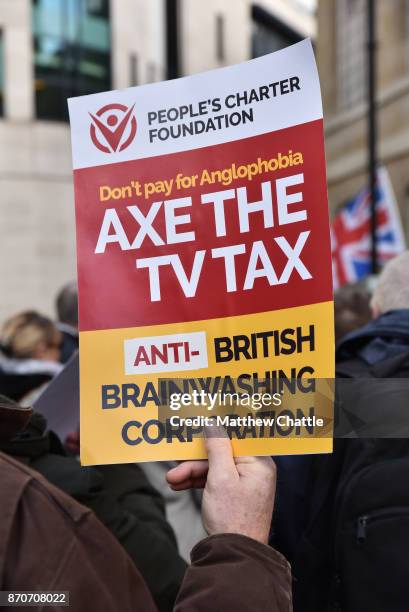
[33, 0, 111, 120]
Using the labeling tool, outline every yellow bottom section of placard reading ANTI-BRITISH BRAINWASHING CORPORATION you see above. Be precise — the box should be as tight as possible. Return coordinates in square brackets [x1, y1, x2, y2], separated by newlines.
[80, 297, 334, 465]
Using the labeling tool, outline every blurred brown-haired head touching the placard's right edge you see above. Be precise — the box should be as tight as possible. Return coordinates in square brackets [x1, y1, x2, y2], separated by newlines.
[334, 282, 372, 342]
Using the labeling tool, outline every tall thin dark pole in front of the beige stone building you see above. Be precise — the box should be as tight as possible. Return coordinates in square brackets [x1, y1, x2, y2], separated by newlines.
[367, 0, 378, 274]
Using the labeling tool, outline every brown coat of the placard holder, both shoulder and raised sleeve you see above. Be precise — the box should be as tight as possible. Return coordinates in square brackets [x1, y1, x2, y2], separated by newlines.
[0, 406, 291, 612]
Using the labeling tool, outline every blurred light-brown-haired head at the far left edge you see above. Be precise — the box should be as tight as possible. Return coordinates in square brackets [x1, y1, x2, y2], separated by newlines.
[0, 311, 62, 361]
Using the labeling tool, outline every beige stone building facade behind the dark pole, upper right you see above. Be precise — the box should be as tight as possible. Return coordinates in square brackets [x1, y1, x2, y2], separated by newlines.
[316, 0, 409, 238]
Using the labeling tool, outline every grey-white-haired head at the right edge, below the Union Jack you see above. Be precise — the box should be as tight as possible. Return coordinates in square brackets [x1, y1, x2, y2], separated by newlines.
[371, 251, 409, 318]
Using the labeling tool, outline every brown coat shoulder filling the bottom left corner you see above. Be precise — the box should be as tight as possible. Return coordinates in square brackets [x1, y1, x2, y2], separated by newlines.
[0, 453, 156, 612]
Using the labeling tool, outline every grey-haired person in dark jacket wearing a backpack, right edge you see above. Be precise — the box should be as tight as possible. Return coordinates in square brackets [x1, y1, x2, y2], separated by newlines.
[280, 251, 409, 612]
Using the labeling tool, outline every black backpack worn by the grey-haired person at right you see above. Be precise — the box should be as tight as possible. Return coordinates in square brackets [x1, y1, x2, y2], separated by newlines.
[293, 351, 409, 612]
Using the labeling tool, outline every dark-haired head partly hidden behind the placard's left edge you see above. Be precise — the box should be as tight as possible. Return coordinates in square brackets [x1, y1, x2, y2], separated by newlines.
[55, 282, 78, 363]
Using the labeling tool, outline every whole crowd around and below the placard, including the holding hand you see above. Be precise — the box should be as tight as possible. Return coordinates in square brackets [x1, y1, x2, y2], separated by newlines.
[0, 252, 409, 612]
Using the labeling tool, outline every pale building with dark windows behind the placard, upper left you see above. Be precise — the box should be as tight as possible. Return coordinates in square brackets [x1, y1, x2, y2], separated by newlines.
[0, 0, 315, 323]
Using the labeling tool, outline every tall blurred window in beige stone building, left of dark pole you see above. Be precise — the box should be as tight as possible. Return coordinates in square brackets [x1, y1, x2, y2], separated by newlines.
[336, 0, 367, 109]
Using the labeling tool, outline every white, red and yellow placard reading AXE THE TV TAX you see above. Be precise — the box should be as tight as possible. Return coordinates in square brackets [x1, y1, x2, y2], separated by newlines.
[69, 40, 334, 464]
